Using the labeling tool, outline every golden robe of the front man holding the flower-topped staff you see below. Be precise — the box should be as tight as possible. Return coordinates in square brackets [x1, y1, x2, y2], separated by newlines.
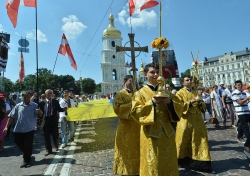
[131, 86, 182, 176]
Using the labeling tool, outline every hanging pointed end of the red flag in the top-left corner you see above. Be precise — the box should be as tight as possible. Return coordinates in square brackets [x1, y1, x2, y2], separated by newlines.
[5, 0, 20, 28]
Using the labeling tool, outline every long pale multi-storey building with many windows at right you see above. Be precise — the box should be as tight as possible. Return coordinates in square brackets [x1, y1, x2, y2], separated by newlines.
[191, 48, 250, 87]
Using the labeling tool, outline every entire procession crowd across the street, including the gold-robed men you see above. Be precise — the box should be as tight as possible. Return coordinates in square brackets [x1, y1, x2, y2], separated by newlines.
[0, 63, 250, 173]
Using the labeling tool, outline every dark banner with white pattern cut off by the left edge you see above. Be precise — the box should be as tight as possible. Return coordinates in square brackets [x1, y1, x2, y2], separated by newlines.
[0, 35, 9, 72]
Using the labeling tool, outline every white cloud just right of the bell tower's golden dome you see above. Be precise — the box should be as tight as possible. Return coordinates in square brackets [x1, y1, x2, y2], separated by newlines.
[118, 6, 157, 29]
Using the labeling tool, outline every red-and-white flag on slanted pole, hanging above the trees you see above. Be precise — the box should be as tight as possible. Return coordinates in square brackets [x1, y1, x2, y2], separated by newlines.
[58, 34, 77, 70]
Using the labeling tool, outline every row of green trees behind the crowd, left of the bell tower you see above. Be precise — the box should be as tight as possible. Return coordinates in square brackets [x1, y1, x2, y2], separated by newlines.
[4, 68, 101, 95]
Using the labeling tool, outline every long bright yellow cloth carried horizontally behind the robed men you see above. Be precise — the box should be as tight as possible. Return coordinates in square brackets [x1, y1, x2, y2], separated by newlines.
[67, 99, 117, 121]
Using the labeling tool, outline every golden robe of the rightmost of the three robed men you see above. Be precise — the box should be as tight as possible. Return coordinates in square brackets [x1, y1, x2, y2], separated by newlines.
[175, 88, 211, 161]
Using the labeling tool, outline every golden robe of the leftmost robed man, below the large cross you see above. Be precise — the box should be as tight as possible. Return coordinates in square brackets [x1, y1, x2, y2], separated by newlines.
[113, 89, 140, 175]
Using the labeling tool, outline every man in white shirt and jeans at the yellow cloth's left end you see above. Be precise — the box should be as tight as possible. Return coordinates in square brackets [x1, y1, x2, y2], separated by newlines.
[59, 90, 76, 148]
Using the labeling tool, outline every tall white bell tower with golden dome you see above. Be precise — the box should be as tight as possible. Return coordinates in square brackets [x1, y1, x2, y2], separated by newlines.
[101, 14, 126, 95]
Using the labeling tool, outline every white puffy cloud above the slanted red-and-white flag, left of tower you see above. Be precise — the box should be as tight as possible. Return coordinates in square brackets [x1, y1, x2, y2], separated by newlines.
[62, 15, 87, 40]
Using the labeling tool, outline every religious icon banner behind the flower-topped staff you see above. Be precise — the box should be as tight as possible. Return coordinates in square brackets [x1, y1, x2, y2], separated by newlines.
[151, 50, 179, 79]
